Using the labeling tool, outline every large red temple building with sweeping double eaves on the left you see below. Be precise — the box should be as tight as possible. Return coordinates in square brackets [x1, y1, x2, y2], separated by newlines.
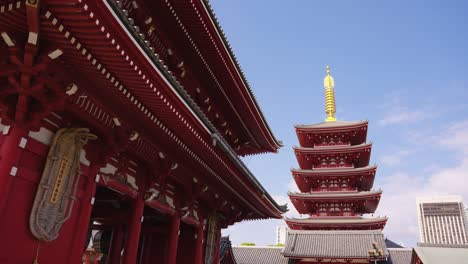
[0, 0, 285, 264]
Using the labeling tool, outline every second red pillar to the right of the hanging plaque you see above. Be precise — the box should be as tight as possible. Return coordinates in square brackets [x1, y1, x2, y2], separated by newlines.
[123, 192, 145, 264]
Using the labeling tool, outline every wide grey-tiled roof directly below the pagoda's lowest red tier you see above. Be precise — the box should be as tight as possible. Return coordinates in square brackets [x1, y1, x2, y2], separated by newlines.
[283, 230, 388, 259]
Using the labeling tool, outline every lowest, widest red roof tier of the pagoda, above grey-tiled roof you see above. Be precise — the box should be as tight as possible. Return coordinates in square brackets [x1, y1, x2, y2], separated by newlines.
[285, 216, 388, 230]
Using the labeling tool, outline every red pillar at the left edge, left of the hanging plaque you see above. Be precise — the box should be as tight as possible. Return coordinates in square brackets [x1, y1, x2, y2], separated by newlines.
[0, 125, 28, 214]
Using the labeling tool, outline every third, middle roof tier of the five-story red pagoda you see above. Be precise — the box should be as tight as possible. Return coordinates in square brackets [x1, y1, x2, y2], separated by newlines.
[291, 165, 377, 192]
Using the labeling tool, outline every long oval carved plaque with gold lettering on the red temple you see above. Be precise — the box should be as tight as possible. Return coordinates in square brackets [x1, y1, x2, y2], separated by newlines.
[29, 128, 97, 241]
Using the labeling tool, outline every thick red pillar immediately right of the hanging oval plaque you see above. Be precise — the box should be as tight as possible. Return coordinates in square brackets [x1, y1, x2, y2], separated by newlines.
[70, 162, 101, 263]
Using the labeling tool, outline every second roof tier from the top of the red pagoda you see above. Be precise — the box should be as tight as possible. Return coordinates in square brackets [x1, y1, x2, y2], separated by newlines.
[293, 143, 372, 169]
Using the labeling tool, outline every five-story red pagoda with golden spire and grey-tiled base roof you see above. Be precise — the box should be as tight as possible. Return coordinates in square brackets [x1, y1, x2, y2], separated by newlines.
[284, 67, 387, 263]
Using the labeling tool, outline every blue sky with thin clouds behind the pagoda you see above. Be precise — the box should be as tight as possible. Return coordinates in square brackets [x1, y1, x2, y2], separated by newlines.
[210, 0, 468, 246]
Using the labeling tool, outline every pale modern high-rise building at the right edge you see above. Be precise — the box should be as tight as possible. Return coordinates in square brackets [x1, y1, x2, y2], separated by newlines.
[416, 196, 468, 244]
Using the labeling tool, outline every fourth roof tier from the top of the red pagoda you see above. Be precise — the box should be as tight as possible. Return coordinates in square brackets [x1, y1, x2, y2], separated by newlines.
[288, 190, 382, 215]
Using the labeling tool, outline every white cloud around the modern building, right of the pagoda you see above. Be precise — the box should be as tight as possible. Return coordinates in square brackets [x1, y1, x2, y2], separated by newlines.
[376, 121, 468, 246]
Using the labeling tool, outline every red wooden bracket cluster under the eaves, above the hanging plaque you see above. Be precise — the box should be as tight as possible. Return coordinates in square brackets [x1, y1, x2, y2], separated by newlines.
[0, 0, 66, 128]
